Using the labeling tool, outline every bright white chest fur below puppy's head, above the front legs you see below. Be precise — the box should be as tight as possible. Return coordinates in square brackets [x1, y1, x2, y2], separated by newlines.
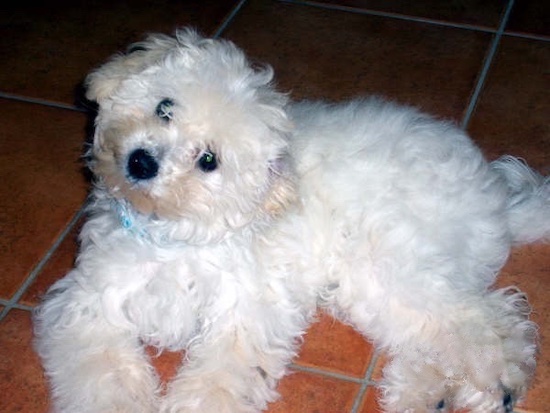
[83, 218, 302, 350]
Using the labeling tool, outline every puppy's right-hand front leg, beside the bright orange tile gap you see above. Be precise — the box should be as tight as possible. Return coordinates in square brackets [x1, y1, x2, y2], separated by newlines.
[161, 313, 302, 413]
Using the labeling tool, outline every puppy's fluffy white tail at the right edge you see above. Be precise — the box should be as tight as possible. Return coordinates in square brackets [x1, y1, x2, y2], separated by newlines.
[491, 156, 550, 244]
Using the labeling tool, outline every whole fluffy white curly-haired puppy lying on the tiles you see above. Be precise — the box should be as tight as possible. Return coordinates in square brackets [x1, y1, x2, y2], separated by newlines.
[35, 30, 550, 413]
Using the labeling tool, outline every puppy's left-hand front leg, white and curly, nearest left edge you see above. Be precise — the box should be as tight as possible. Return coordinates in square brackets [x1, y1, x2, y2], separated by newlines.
[34, 280, 158, 413]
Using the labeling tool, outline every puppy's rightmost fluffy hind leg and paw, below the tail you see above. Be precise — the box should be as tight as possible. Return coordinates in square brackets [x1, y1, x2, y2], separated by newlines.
[446, 288, 537, 413]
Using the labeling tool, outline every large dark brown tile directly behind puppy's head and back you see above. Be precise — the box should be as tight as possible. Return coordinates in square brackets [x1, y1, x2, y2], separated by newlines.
[224, 1, 491, 119]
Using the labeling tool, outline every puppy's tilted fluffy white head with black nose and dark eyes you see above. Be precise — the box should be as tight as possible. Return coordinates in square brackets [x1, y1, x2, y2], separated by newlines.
[87, 30, 294, 242]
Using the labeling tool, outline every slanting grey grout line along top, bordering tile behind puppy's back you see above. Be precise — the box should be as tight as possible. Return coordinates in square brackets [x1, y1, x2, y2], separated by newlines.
[278, 0, 497, 33]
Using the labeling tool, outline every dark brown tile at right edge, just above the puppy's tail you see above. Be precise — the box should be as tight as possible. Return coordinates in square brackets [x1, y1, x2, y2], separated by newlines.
[468, 37, 550, 174]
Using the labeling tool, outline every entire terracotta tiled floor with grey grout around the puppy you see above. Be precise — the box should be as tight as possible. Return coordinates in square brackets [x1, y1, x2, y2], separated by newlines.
[0, 0, 550, 413]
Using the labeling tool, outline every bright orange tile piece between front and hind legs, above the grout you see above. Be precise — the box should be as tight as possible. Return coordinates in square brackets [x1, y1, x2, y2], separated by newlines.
[296, 313, 374, 378]
